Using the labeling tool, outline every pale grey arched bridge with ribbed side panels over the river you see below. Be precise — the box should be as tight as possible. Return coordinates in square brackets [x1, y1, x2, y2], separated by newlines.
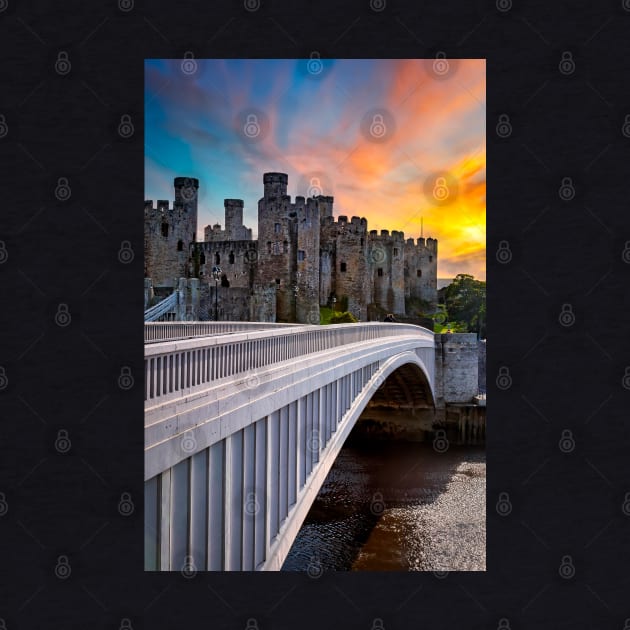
[144, 322, 435, 571]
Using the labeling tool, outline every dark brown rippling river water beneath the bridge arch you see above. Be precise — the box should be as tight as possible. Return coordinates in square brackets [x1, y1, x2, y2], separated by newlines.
[282, 442, 486, 571]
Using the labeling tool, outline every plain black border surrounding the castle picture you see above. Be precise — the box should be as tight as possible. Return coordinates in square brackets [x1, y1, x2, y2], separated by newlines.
[0, 0, 630, 630]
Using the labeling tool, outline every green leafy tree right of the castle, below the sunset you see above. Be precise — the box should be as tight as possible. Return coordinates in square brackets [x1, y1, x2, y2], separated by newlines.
[444, 273, 486, 338]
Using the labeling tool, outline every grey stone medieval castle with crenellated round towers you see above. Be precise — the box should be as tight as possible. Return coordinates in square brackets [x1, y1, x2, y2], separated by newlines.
[144, 173, 437, 323]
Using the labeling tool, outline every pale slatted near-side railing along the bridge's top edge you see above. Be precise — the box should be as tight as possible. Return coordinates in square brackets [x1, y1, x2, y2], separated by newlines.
[144, 322, 434, 406]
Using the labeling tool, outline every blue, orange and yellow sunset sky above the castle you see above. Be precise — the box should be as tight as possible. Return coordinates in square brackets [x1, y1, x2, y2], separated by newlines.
[145, 59, 486, 280]
